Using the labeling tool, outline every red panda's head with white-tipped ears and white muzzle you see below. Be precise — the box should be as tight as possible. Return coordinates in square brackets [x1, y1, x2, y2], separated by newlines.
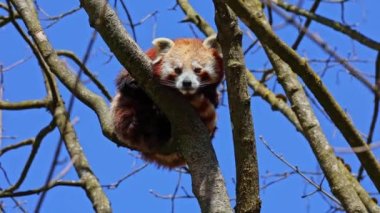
[147, 36, 223, 94]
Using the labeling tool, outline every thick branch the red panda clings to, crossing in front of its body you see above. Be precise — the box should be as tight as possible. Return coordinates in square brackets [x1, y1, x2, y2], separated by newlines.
[81, 0, 231, 212]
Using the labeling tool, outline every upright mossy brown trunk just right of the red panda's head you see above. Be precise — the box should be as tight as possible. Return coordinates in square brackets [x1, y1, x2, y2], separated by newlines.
[214, 0, 261, 213]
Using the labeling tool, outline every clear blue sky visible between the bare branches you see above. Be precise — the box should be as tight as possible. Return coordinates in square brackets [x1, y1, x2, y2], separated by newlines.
[0, 0, 380, 213]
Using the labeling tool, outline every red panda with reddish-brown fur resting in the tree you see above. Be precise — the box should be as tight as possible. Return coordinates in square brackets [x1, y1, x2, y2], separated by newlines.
[111, 36, 224, 168]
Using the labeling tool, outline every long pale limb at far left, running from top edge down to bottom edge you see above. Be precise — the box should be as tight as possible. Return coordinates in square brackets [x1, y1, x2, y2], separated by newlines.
[12, 0, 111, 212]
